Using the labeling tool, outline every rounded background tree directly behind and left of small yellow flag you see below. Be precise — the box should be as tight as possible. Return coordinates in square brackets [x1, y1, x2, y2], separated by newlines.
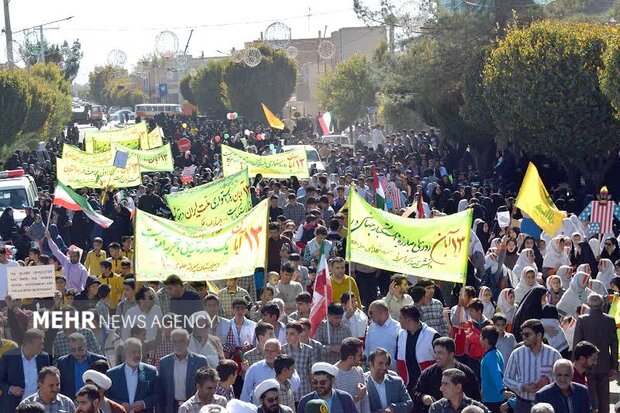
[224, 44, 297, 120]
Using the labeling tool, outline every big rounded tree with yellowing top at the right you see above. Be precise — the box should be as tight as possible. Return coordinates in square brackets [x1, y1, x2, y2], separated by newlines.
[483, 21, 620, 184]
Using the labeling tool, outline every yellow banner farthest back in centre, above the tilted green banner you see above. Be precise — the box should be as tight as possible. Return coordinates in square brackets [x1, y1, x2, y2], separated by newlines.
[222, 145, 310, 178]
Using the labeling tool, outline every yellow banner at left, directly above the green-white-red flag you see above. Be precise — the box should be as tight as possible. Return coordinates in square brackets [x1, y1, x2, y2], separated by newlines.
[56, 157, 142, 189]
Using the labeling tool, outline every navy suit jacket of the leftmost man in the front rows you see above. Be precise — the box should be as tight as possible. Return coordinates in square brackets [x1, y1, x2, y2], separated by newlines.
[0, 347, 50, 412]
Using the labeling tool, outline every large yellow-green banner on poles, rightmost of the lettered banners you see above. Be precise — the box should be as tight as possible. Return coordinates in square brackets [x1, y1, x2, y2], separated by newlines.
[347, 189, 472, 283]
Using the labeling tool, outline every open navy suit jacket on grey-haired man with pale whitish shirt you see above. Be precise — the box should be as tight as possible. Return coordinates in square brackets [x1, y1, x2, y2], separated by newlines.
[159, 352, 207, 412]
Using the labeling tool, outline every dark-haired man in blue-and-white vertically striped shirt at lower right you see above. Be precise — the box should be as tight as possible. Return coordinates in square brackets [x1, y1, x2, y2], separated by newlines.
[504, 319, 562, 413]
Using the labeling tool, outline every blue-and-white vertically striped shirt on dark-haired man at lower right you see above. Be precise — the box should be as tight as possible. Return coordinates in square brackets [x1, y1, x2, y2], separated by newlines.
[504, 344, 562, 401]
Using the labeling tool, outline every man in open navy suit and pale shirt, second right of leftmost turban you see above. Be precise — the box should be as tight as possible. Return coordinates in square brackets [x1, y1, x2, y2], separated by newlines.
[159, 328, 207, 412]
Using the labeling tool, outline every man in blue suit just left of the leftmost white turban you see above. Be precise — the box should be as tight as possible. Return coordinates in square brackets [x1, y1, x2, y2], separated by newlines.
[56, 333, 105, 399]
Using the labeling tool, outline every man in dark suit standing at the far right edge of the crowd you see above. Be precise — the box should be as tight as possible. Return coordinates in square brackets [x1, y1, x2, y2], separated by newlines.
[573, 294, 618, 413]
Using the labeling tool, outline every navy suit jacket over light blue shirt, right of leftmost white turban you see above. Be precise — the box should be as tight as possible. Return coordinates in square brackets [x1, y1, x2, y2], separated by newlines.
[106, 363, 161, 413]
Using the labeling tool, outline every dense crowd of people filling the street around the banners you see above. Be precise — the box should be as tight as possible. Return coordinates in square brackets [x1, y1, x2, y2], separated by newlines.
[0, 112, 620, 413]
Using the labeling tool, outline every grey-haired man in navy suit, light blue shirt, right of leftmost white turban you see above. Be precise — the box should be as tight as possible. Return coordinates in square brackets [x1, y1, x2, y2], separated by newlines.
[107, 337, 161, 413]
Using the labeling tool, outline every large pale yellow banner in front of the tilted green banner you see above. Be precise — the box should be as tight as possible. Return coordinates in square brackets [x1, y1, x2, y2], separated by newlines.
[135, 200, 269, 281]
